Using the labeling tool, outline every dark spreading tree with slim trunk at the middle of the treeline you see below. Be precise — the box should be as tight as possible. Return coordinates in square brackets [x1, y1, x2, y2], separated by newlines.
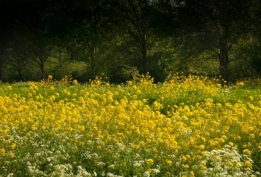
[111, 0, 156, 73]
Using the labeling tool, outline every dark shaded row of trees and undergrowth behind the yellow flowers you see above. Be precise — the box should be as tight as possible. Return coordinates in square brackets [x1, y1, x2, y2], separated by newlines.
[0, 0, 261, 82]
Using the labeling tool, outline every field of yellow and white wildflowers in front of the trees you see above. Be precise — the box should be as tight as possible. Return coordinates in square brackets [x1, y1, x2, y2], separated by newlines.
[0, 75, 261, 177]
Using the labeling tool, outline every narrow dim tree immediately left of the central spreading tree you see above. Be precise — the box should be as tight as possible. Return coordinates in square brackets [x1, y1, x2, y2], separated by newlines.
[70, 0, 110, 76]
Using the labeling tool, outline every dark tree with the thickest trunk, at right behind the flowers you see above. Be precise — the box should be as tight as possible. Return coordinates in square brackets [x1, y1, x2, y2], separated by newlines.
[179, 0, 251, 82]
